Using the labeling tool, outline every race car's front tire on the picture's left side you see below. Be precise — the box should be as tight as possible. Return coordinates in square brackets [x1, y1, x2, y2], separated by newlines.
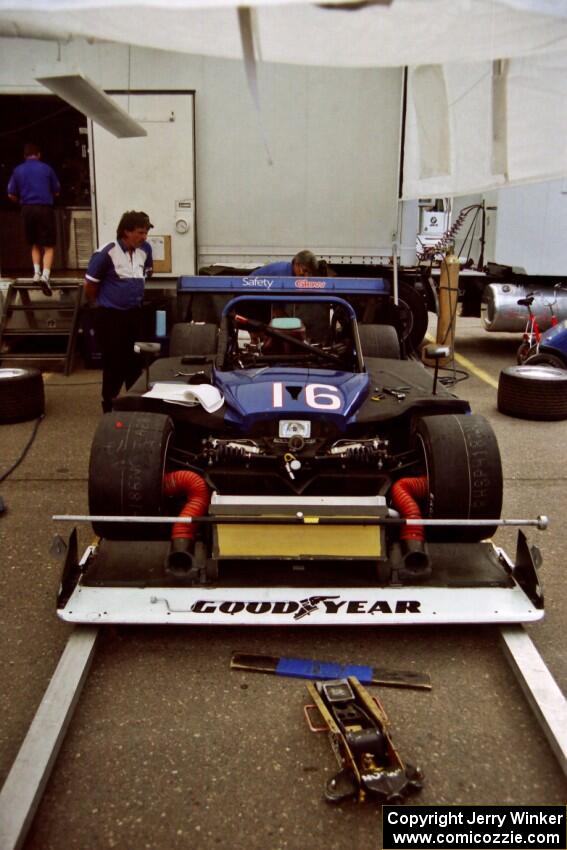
[89, 411, 173, 540]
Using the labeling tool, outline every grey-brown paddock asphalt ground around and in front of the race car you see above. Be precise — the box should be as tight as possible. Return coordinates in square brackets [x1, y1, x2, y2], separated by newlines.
[0, 318, 567, 850]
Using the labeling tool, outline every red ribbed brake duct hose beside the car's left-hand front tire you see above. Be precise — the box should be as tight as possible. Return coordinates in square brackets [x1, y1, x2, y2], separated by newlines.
[163, 469, 210, 575]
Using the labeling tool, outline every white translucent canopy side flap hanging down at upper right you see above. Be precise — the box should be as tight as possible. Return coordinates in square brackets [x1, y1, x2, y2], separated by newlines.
[403, 54, 567, 198]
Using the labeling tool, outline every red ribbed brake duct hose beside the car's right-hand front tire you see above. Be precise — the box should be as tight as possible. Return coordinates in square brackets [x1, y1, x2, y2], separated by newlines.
[390, 475, 430, 577]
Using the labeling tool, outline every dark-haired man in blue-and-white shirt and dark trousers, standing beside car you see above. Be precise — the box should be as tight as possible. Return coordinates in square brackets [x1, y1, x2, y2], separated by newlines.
[85, 210, 153, 413]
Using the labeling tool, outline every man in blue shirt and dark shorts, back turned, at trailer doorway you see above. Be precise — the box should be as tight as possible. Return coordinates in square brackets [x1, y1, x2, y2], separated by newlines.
[8, 143, 61, 295]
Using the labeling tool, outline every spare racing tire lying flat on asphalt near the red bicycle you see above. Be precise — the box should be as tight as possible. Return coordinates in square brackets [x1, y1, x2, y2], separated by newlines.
[498, 364, 567, 422]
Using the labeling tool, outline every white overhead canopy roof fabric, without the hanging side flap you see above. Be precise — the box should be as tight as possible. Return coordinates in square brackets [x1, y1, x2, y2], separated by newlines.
[0, 0, 567, 67]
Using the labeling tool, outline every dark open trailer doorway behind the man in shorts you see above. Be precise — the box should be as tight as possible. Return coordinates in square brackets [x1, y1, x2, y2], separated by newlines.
[0, 95, 93, 277]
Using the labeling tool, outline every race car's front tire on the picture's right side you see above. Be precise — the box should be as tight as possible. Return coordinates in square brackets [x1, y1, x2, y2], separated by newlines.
[416, 414, 502, 543]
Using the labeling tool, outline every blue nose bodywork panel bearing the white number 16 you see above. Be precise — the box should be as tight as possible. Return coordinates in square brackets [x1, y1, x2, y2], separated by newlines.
[214, 367, 370, 434]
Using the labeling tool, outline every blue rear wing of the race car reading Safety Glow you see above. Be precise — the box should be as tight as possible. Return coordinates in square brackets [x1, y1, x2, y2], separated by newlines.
[177, 275, 391, 295]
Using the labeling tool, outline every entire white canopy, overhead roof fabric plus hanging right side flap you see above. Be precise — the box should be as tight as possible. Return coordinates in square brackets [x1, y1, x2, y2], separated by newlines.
[0, 0, 567, 198]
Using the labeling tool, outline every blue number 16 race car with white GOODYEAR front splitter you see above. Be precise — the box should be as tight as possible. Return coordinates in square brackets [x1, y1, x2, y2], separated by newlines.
[59, 278, 543, 623]
